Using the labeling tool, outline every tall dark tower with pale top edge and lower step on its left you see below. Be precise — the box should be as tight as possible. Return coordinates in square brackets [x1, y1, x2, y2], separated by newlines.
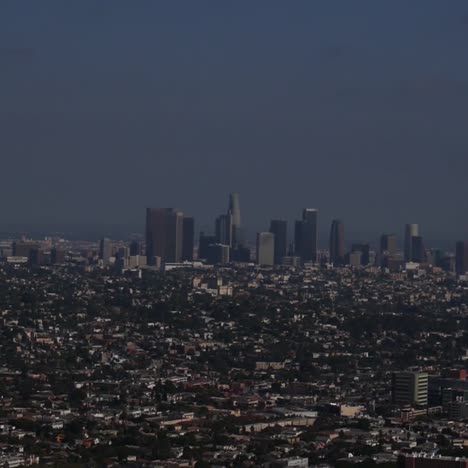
[294, 208, 318, 262]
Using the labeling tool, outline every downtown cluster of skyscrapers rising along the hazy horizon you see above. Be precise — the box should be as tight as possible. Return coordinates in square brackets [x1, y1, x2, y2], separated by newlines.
[146, 193, 468, 274]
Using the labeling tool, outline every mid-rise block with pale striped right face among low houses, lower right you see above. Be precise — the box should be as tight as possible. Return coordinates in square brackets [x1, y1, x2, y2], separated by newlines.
[392, 372, 429, 406]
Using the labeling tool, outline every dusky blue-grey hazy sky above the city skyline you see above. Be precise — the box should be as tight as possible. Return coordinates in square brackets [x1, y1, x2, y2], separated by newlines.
[0, 0, 468, 247]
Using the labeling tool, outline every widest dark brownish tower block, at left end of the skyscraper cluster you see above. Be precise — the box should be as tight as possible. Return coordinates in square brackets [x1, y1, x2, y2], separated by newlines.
[146, 208, 184, 265]
